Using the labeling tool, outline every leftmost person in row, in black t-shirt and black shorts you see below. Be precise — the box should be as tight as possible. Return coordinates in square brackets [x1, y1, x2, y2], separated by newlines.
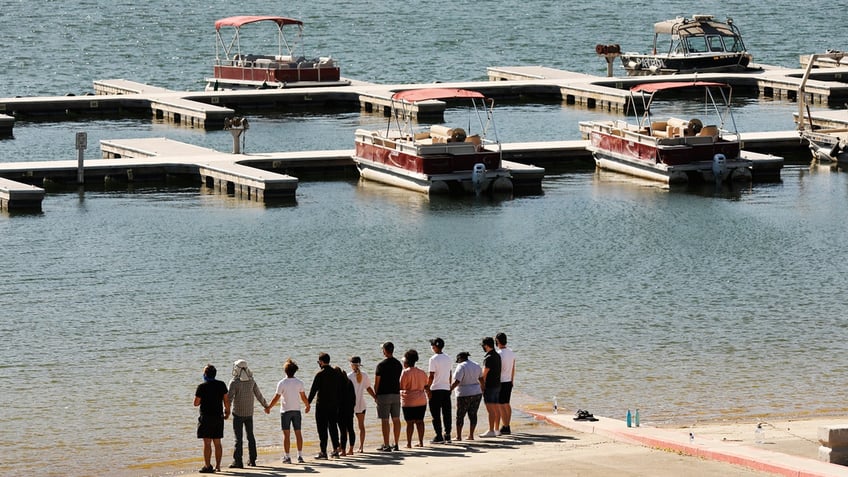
[194, 364, 230, 474]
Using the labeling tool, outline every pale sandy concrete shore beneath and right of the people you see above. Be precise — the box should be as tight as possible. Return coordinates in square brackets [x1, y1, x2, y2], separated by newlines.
[167, 414, 848, 477]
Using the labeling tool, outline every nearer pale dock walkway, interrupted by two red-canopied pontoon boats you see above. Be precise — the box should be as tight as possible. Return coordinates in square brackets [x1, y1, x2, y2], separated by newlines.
[0, 131, 805, 210]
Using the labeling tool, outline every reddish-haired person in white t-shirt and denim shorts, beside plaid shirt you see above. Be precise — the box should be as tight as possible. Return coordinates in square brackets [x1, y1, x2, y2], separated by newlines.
[265, 358, 309, 464]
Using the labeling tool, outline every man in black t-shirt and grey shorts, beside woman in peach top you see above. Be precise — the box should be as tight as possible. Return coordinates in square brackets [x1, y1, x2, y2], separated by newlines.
[374, 341, 403, 452]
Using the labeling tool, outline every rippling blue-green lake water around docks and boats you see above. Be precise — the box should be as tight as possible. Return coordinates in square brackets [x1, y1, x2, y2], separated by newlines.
[0, 0, 848, 476]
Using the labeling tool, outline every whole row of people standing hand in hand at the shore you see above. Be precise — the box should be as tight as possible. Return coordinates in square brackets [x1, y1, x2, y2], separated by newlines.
[194, 333, 515, 473]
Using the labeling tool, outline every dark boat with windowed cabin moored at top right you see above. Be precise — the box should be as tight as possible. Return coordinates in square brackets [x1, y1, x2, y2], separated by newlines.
[619, 15, 752, 76]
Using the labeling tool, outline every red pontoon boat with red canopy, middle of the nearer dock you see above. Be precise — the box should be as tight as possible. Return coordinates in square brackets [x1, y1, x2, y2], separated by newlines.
[353, 88, 513, 194]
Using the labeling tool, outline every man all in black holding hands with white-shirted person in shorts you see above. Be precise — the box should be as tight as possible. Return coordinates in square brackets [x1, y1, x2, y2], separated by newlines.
[307, 353, 342, 459]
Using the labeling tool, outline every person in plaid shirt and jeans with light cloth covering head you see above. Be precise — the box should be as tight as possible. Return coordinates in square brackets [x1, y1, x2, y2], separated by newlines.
[225, 359, 268, 469]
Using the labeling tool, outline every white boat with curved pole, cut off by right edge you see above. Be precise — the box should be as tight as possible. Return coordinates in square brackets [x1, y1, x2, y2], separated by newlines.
[797, 50, 848, 166]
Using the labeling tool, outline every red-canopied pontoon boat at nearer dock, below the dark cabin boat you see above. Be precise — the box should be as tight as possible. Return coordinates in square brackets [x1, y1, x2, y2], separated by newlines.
[580, 81, 752, 184]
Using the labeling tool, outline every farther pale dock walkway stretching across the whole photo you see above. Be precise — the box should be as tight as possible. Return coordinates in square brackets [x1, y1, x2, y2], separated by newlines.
[0, 66, 848, 132]
